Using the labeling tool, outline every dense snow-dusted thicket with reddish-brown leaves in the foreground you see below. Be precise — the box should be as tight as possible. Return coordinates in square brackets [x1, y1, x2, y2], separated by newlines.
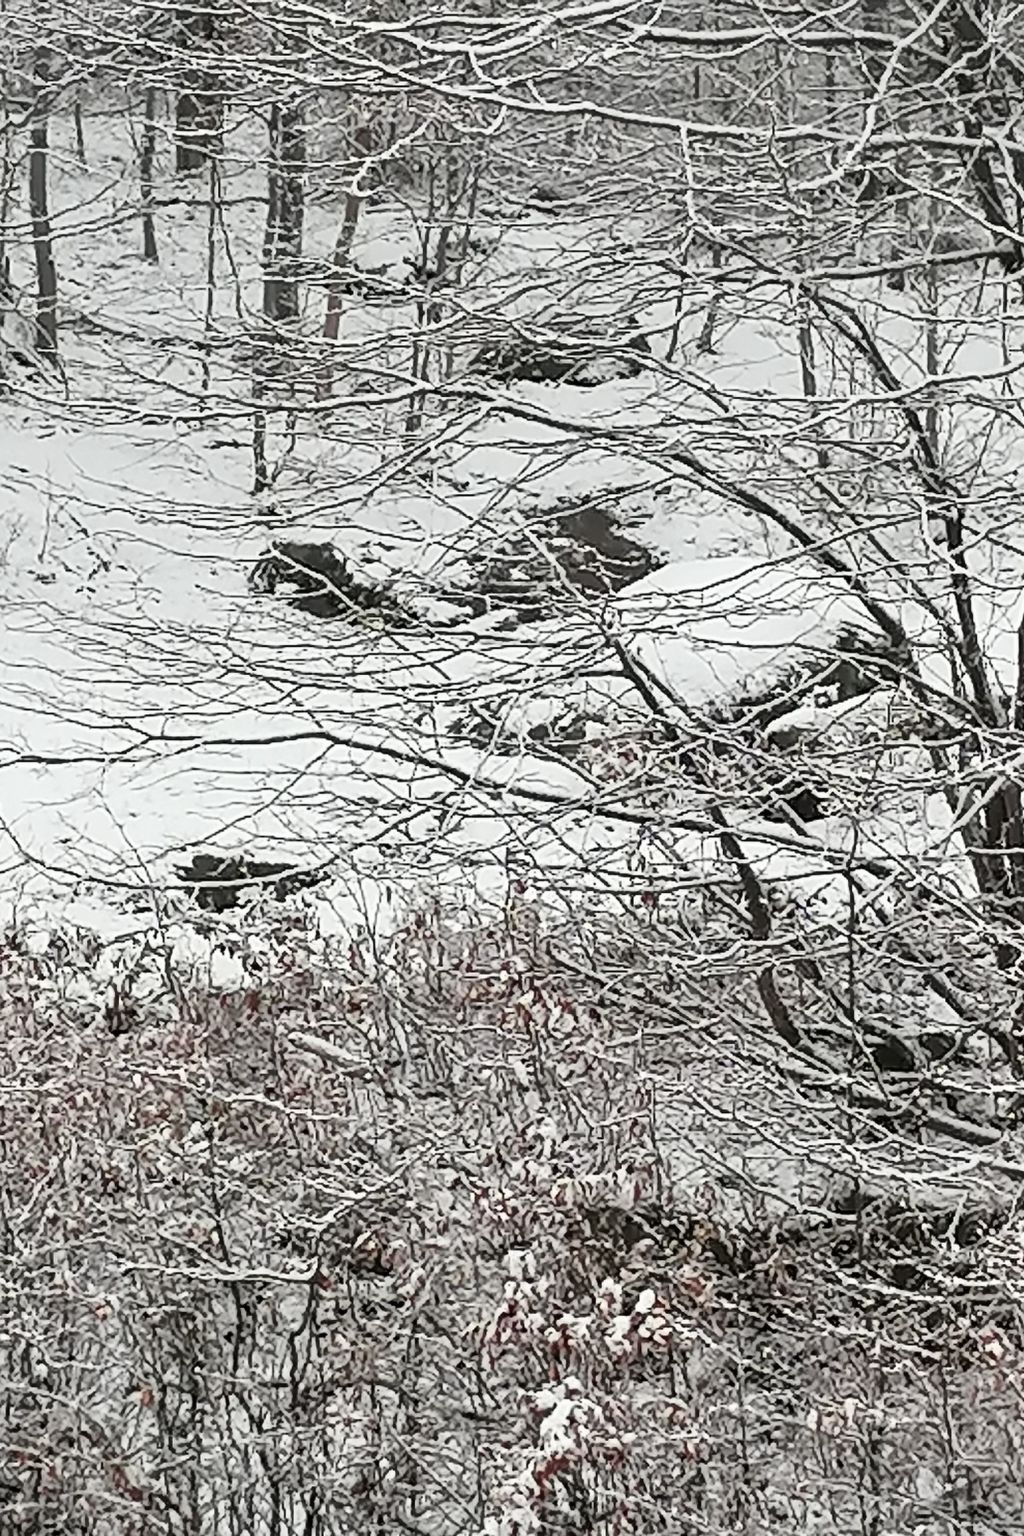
[0, 884, 1021, 1536]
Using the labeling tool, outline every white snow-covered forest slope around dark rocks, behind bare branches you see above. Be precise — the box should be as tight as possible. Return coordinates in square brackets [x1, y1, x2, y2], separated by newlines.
[0, 108, 1024, 983]
